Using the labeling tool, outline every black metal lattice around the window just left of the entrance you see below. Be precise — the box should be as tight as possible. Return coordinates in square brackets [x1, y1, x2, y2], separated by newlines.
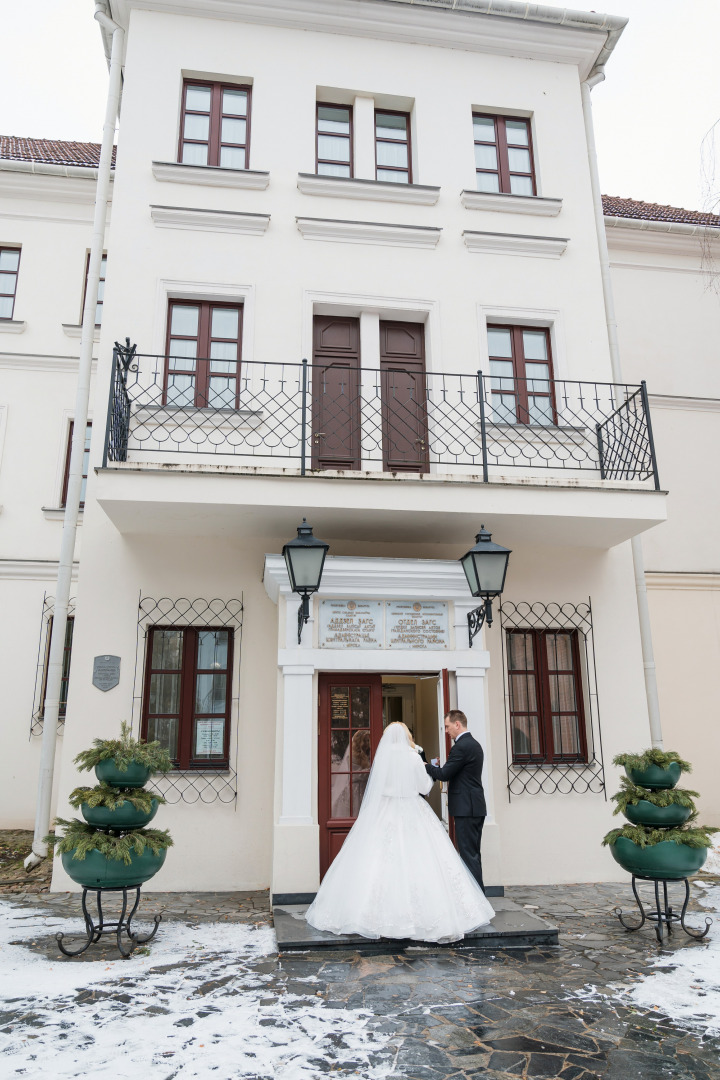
[133, 593, 243, 805]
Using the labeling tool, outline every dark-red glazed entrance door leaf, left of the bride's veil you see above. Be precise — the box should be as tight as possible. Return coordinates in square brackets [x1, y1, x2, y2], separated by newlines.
[317, 675, 382, 878]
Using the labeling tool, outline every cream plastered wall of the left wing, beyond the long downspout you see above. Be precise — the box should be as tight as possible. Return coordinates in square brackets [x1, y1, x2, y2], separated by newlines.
[0, 172, 101, 828]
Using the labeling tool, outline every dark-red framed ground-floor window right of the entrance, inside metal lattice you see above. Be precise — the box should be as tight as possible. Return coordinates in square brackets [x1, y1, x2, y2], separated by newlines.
[507, 630, 587, 764]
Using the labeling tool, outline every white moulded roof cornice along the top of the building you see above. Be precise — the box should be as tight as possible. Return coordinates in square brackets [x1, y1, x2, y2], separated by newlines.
[111, 0, 627, 79]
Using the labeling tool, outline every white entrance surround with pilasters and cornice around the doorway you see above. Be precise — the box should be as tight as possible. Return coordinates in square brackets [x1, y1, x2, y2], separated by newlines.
[263, 555, 500, 902]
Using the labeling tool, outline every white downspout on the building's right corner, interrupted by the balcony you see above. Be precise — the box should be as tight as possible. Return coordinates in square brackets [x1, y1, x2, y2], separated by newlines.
[581, 70, 663, 750]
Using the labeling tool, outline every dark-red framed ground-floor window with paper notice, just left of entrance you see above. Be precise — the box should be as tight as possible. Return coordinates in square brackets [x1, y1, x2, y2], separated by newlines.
[142, 626, 233, 769]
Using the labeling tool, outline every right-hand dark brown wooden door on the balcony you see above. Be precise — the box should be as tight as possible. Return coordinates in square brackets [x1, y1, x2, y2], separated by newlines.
[380, 322, 429, 472]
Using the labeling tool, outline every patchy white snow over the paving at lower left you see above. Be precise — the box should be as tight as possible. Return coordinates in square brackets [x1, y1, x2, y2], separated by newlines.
[0, 902, 392, 1080]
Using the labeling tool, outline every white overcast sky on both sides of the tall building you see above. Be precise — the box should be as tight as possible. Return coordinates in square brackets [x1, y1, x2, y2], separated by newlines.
[0, 0, 720, 210]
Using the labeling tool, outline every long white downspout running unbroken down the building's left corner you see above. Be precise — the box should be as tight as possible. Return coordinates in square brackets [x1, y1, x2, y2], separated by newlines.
[25, 3, 124, 870]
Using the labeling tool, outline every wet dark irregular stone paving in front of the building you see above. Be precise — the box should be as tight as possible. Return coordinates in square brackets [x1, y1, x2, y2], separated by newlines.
[0, 878, 720, 1080]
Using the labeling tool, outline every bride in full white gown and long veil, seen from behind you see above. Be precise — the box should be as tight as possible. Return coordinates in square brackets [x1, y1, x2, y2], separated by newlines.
[305, 724, 494, 942]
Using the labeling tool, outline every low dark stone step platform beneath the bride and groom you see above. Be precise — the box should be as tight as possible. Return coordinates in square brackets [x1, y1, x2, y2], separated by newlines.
[272, 896, 558, 953]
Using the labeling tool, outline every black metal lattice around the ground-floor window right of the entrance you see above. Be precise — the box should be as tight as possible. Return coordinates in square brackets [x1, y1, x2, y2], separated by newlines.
[500, 597, 608, 799]
